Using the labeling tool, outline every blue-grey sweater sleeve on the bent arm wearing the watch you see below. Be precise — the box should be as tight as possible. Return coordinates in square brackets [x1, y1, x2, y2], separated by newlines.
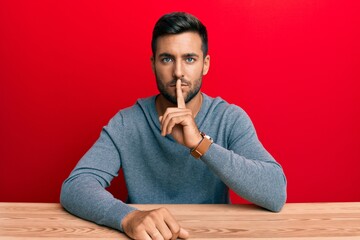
[201, 108, 286, 212]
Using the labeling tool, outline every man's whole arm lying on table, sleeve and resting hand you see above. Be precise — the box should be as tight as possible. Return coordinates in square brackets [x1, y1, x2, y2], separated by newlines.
[60, 116, 189, 239]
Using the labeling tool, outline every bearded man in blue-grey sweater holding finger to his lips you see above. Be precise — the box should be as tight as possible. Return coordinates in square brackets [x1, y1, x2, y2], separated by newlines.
[61, 12, 286, 239]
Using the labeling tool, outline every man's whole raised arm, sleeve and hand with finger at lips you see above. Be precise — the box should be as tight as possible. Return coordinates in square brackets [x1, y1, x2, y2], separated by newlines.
[160, 80, 286, 212]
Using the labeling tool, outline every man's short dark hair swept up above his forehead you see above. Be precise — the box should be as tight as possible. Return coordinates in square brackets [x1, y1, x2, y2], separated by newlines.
[151, 12, 208, 57]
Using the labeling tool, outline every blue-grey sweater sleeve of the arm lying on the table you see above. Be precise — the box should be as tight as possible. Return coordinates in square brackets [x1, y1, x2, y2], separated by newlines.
[60, 116, 135, 231]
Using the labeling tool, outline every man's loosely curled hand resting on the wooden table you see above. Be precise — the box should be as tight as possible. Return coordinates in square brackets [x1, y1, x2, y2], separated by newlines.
[122, 208, 189, 240]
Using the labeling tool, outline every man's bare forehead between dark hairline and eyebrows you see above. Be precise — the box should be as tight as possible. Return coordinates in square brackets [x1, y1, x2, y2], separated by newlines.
[156, 32, 202, 56]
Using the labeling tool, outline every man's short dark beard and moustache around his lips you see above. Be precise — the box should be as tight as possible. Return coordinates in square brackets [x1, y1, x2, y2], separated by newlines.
[155, 71, 202, 105]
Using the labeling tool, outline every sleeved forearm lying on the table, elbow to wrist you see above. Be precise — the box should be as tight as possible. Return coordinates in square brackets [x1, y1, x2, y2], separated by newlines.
[60, 174, 135, 231]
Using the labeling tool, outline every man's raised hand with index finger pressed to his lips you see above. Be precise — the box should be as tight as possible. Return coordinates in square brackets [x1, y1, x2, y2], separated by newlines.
[159, 79, 202, 149]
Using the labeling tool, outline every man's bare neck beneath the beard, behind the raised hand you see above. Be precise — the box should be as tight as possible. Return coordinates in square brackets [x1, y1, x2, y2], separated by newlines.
[155, 91, 203, 117]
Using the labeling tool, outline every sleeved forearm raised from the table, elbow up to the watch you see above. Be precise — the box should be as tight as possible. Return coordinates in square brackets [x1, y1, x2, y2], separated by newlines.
[201, 144, 286, 212]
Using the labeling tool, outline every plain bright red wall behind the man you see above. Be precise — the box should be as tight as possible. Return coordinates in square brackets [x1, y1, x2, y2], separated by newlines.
[0, 0, 360, 202]
